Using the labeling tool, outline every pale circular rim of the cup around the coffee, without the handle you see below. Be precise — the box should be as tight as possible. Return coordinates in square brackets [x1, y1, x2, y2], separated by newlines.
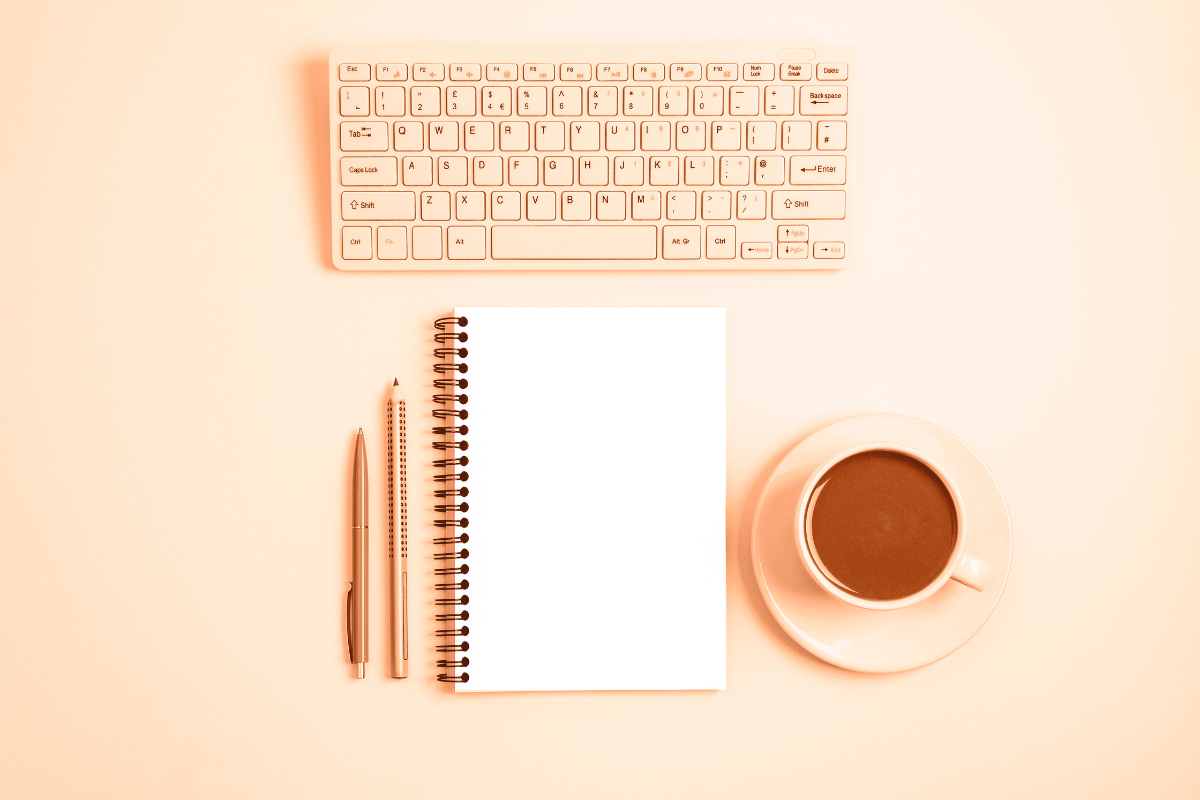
[792, 441, 966, 610]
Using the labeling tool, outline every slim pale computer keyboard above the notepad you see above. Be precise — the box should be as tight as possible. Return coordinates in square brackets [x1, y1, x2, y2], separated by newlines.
[329, 46, 858, 270]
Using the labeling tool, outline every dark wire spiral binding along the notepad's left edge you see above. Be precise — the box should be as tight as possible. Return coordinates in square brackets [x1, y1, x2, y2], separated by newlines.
[433, 317, 470, 684]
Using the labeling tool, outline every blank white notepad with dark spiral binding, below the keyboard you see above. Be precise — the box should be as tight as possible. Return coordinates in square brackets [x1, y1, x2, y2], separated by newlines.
[433, 308, 725, 692]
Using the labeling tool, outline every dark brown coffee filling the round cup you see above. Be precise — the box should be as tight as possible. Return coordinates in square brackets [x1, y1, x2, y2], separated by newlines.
[806, 450, 958, 601]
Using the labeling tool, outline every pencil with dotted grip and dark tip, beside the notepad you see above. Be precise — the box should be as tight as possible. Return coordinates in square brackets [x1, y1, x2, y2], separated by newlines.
[388, 380, 408, 678]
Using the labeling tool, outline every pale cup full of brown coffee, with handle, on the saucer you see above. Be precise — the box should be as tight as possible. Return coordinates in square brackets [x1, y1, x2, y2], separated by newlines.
[794, 443, 992, 610]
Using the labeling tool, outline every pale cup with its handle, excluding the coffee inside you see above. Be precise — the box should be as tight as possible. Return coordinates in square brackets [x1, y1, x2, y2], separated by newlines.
[794, 441, 992, 610]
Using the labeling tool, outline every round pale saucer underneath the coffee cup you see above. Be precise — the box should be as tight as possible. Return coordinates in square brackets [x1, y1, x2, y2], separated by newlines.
[750, 414, 1013, 672]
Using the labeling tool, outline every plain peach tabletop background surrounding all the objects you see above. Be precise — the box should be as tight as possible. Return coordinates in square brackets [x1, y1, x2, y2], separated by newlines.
[0, 0, 1200, 798]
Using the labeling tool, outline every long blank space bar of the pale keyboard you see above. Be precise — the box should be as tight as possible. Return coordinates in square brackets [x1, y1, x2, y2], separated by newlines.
[492, 225, 659, 261]
